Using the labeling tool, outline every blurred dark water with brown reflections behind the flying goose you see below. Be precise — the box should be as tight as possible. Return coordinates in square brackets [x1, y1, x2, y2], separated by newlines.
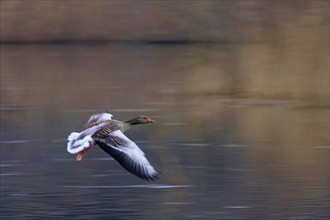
[0, 45, 330, 219]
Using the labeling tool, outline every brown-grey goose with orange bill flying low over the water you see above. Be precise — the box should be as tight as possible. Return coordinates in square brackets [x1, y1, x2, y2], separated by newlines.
[67, 113, 158, 181]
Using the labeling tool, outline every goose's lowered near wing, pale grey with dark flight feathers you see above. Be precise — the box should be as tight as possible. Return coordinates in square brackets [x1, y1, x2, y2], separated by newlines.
[96, 130, 158, 180]
